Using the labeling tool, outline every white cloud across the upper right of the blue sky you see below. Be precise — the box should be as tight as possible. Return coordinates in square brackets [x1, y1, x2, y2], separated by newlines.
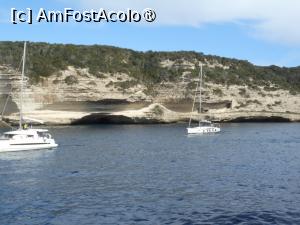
[76, 0, 300, 46]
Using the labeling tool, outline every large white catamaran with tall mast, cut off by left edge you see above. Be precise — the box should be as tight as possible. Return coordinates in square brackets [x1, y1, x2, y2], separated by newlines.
[0, 42, 58, 152]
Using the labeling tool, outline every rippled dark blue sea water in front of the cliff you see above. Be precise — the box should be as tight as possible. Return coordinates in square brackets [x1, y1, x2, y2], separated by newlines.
[0, 123, 300, 225]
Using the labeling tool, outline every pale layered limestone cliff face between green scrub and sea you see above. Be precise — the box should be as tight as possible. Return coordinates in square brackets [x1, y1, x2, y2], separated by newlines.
[0, 41, 300, 124]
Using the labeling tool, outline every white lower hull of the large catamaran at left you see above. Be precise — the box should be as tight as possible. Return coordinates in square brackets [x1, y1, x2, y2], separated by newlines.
[0, 143, 58, 152]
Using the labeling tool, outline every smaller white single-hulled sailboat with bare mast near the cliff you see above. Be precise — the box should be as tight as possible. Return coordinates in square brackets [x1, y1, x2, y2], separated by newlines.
[187, 64, 221, 134]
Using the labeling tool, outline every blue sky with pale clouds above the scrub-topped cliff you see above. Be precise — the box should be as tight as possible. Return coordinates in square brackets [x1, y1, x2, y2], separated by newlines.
[0, 0, 300, 67]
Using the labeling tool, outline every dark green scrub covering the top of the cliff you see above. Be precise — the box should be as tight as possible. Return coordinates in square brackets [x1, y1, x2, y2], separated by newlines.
[0, 42, 300, 93]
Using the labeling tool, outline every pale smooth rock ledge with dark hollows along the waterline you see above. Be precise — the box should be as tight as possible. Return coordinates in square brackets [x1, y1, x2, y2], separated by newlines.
[5, 103, 300, 126]
